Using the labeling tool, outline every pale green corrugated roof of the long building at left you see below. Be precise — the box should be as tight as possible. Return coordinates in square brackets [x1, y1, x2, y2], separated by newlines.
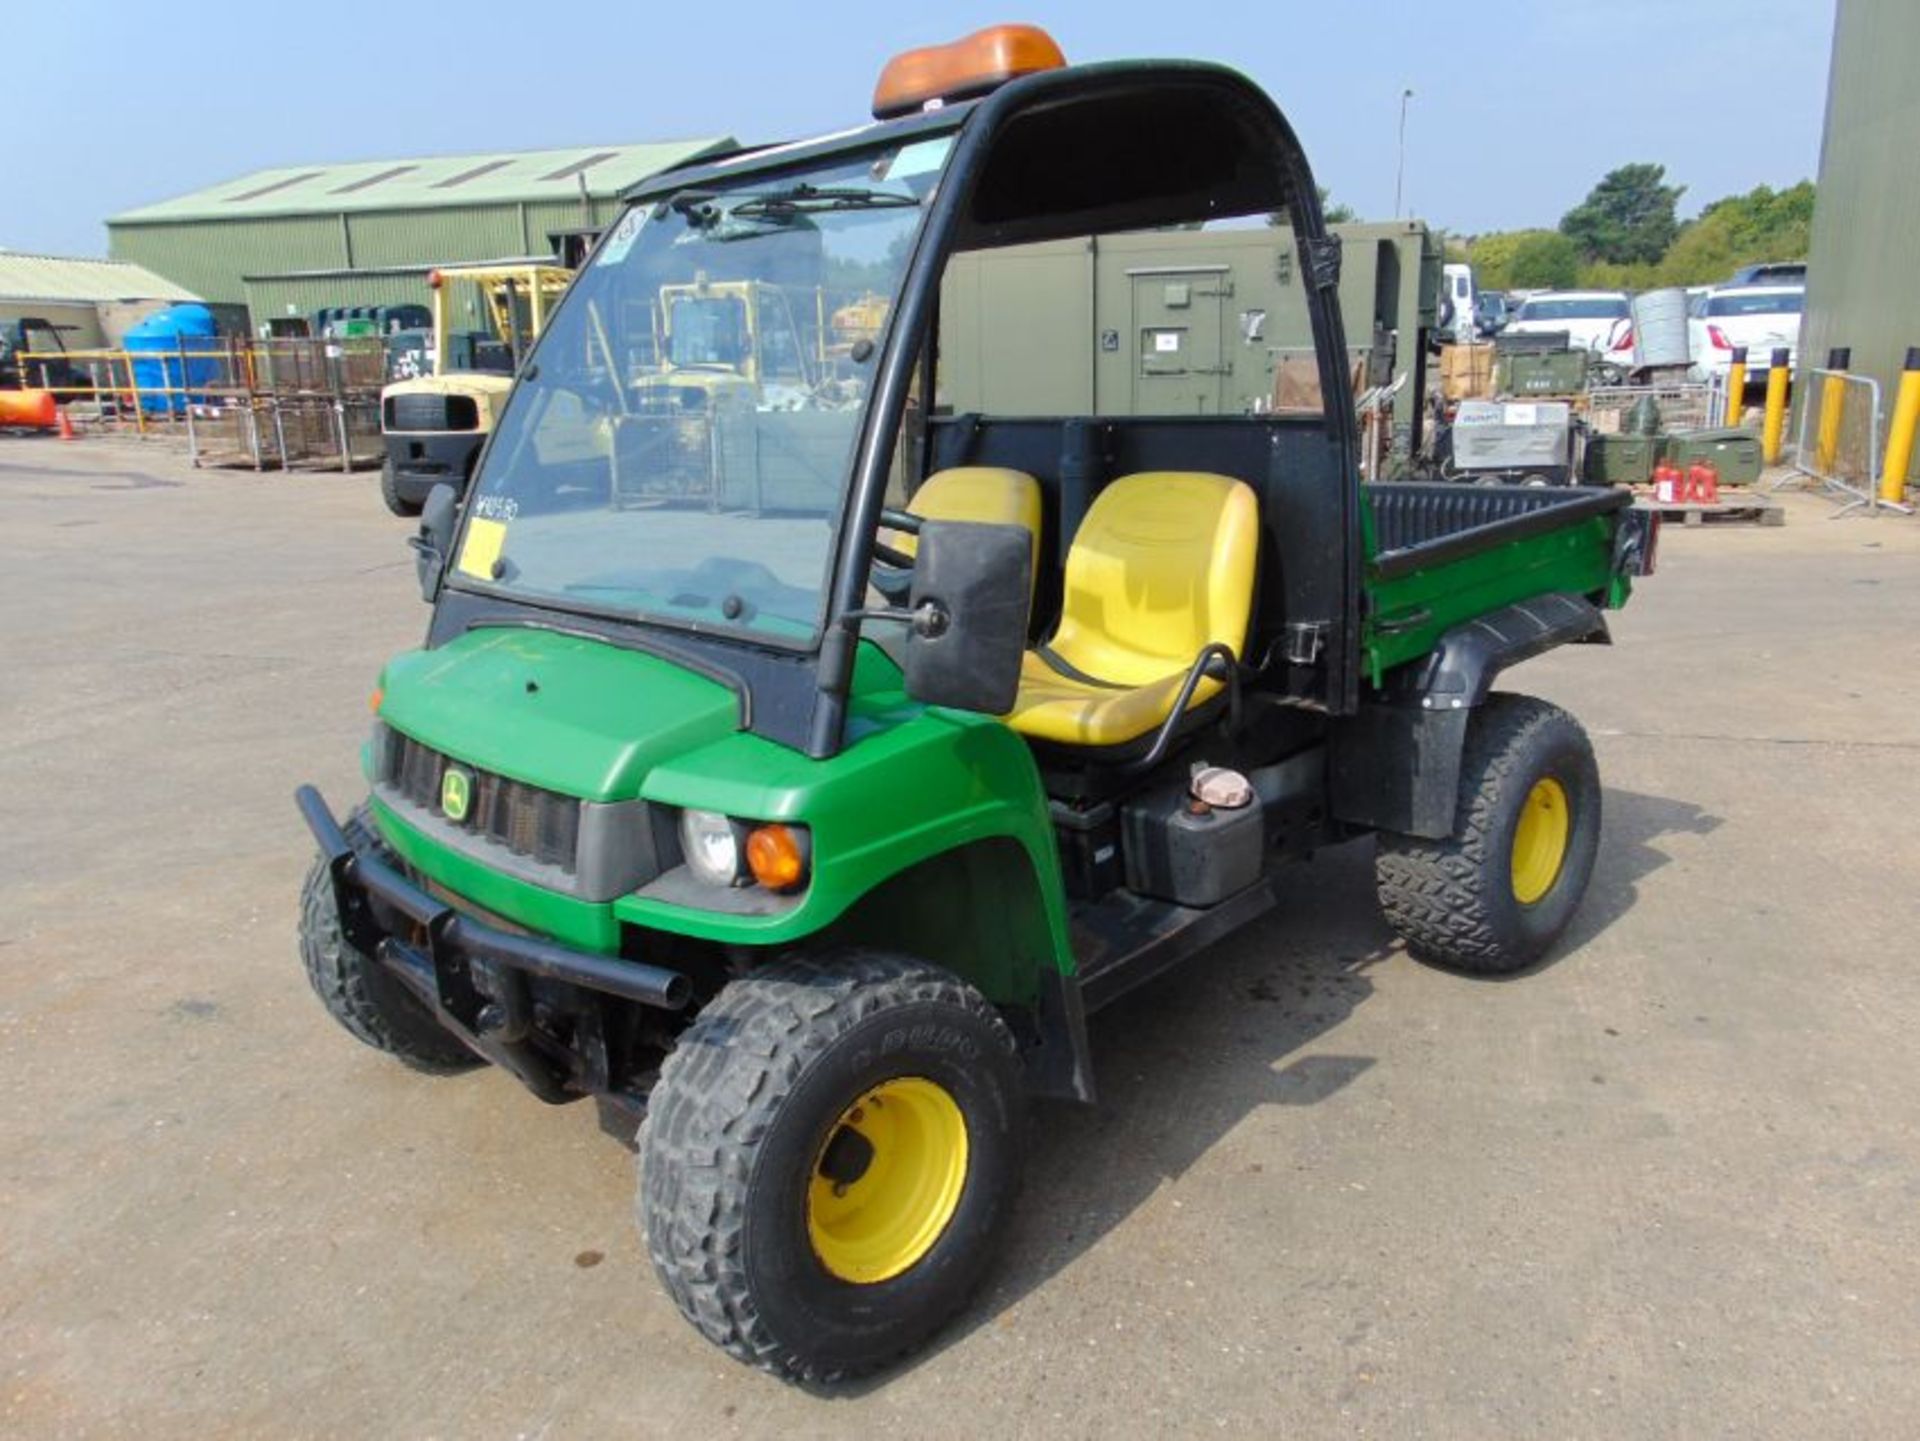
[108, 136, 733, 224]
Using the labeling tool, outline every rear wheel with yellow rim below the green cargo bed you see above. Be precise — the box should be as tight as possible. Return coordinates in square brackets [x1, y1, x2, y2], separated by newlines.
[1373, 695, 1599, 975]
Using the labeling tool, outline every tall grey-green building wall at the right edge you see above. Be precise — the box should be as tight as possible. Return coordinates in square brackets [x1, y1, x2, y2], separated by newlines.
[1799, 0, 1920, 482]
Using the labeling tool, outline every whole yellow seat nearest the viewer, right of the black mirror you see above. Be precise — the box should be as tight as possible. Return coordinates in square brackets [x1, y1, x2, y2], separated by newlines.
[1006, 470, 1260, 746]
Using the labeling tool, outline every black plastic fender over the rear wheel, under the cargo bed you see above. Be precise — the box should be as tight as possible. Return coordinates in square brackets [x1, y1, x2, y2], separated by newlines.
[1329, 593, 1613, 840]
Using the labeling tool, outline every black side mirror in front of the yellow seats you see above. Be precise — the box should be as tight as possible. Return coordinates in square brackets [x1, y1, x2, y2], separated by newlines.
[906, 520, 1033, 716]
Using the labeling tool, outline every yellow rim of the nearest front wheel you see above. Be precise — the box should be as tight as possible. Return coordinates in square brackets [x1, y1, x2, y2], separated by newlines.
[806, 1076, 968, 1286]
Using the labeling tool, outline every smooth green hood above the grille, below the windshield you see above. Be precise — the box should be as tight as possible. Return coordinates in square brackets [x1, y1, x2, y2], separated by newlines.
[380, 627, 739, 800]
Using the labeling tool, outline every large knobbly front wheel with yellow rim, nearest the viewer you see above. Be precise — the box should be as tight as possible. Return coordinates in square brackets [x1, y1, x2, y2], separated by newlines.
[639, 950, 1025, 1382]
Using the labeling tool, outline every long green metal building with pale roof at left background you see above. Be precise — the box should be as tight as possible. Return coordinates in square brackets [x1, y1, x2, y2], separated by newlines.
[108, 136, 733, 326]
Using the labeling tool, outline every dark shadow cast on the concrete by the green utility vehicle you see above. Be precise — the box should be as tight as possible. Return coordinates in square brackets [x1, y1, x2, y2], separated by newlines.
[810, 789, 1722, 1397]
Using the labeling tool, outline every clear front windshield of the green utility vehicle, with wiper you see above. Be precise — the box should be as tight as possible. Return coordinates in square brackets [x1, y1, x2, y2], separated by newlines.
[453, 136, 952, 647]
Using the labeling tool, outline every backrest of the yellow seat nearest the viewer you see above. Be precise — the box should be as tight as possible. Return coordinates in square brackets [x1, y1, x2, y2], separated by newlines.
[1050, 470, 1260, 685]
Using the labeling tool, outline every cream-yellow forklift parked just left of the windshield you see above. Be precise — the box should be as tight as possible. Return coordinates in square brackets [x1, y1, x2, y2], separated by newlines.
[380, 261, 574, 516]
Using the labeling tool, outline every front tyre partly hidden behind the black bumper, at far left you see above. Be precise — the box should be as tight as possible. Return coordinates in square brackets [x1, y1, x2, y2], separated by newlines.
[300, 806, 482, 1075]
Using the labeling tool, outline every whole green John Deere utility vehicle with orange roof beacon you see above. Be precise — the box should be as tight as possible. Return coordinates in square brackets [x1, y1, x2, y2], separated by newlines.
[300, 27, 1651, 1380]
